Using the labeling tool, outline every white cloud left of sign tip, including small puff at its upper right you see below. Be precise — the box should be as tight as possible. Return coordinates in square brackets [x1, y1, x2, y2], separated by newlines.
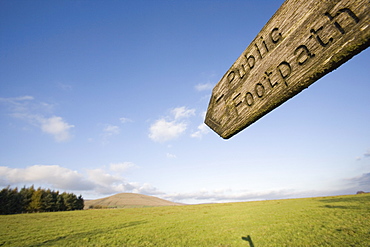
[149, 106, 195, 142]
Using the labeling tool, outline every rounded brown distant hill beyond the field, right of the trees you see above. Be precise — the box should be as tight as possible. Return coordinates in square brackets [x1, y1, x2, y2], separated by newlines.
[84, 193, 183, 209]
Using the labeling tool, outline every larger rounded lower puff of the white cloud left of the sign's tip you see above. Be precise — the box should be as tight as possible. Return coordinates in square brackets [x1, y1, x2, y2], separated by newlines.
[149, 119, 187, 142]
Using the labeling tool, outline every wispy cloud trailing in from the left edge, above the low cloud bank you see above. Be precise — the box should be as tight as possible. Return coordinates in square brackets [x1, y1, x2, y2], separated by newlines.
[0, 96, 74, 142]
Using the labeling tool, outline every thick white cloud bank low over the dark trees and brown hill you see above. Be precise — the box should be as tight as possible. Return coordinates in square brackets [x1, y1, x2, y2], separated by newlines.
[0, 165, 161, 196]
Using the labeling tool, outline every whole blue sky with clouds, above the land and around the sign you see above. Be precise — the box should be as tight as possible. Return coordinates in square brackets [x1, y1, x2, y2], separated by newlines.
[0, 0, 370, 203]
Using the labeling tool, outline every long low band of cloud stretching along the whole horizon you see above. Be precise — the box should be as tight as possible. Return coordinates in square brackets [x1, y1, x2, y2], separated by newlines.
[0, 162, 364, 203]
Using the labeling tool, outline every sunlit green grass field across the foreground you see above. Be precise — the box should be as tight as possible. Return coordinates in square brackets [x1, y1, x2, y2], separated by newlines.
[0, 194, 370, 247]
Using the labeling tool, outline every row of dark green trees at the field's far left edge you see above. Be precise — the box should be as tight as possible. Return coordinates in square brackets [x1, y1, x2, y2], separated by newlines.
[0, 185, 84, 214]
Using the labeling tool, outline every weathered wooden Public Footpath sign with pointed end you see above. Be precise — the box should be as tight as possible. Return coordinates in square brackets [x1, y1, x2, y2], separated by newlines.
[205, 0, 370, 139]
